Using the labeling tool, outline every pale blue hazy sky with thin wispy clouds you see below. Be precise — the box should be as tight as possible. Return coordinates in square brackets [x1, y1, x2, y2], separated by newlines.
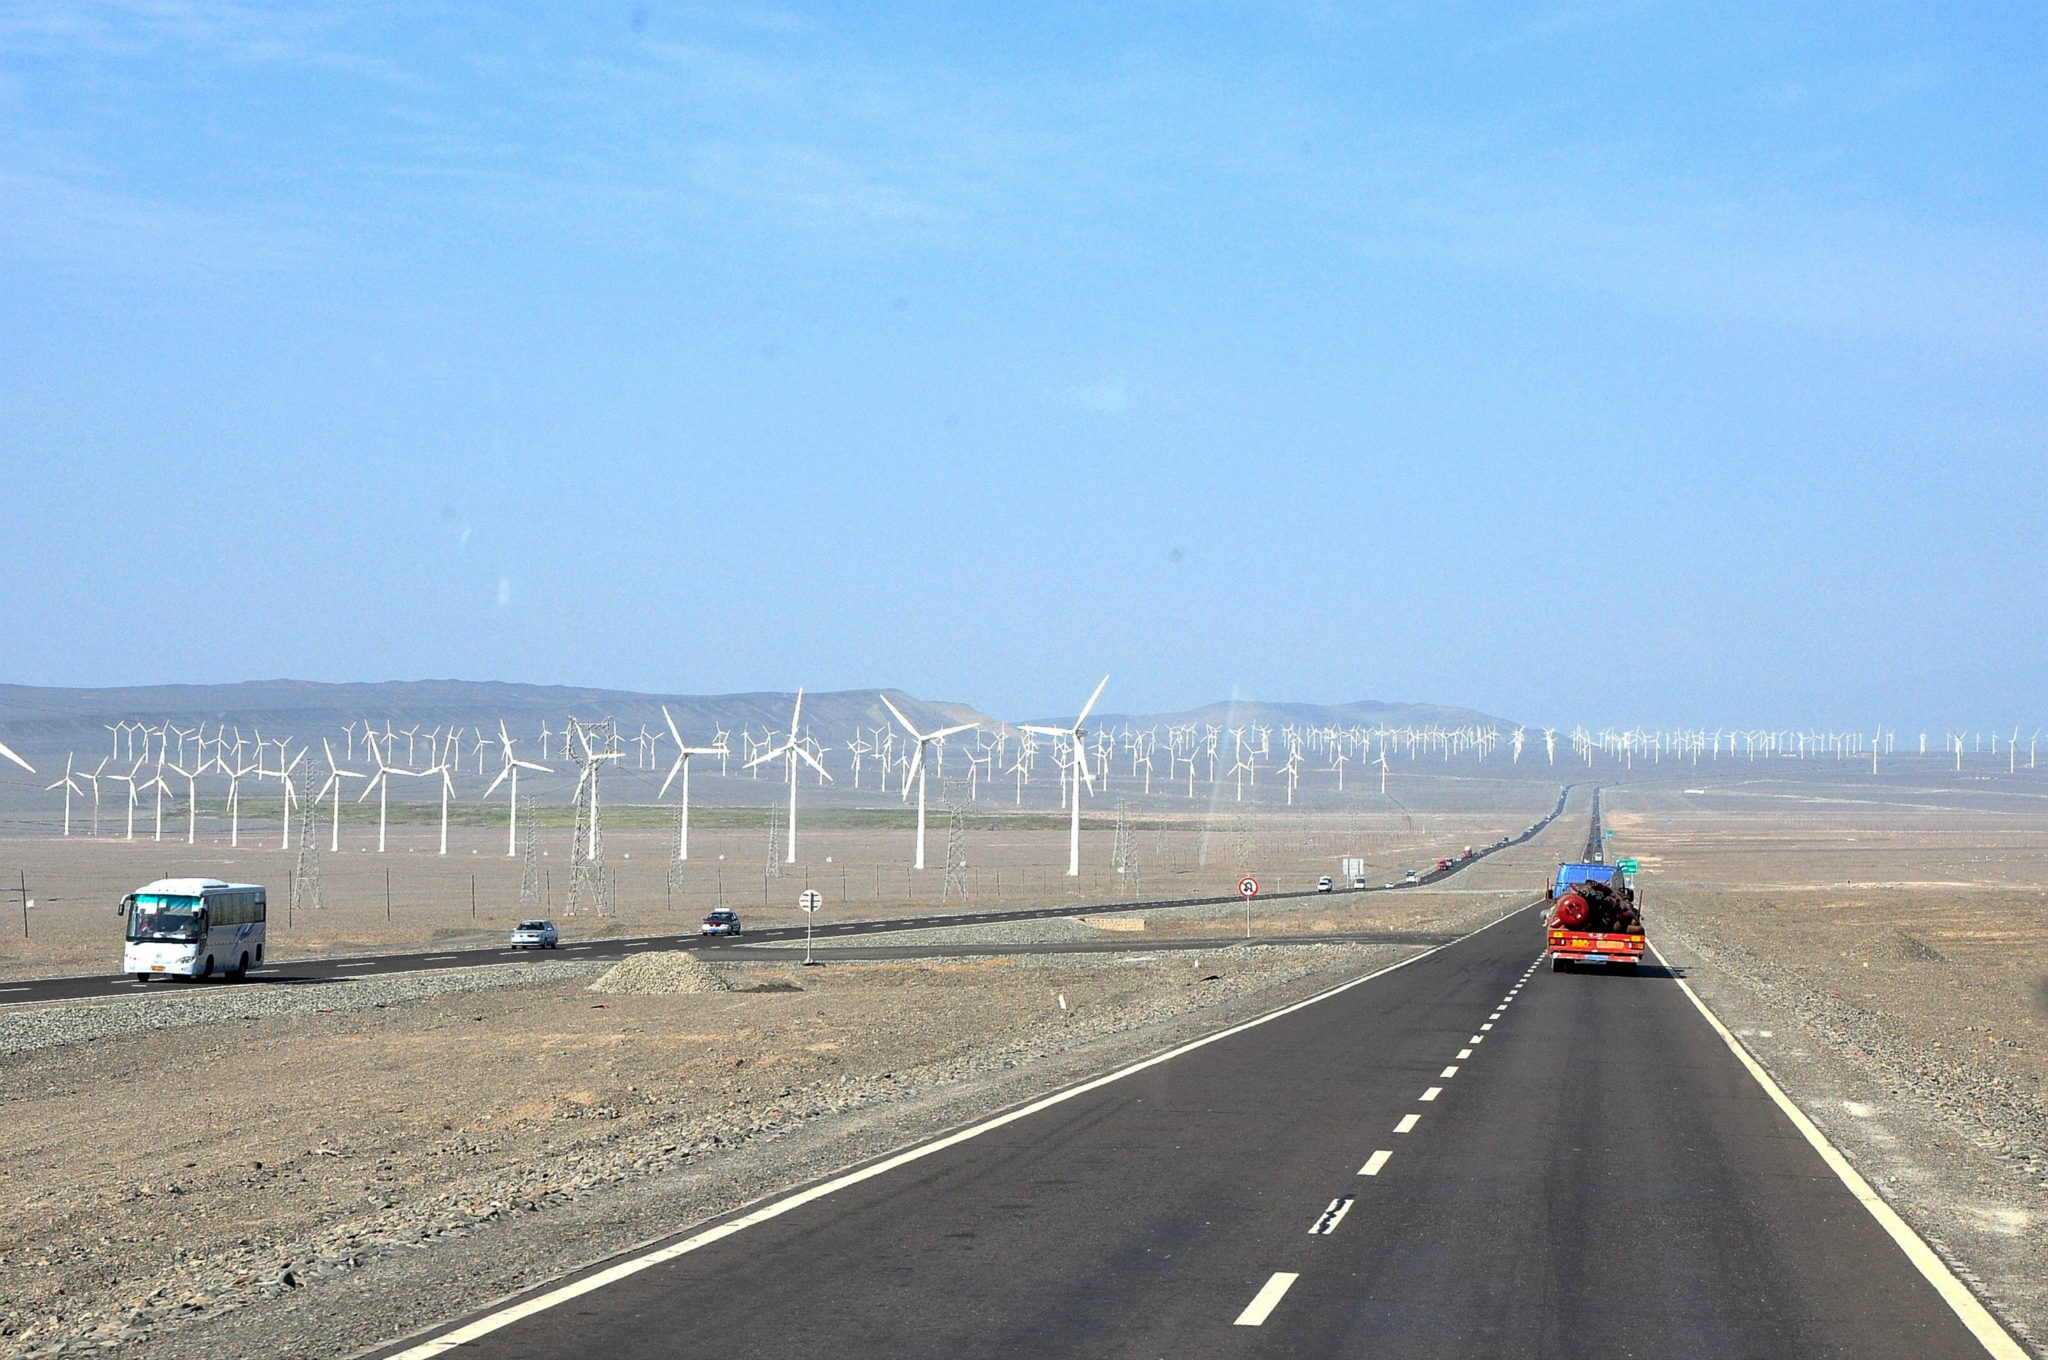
[0, 0, 2048, 731]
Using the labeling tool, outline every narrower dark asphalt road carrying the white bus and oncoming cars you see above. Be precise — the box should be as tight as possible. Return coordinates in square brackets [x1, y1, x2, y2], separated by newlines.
[0, 784, 1572, 1006]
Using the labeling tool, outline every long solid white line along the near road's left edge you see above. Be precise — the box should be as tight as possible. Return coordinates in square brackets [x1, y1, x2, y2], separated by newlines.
[376, 903, 1536, 1360]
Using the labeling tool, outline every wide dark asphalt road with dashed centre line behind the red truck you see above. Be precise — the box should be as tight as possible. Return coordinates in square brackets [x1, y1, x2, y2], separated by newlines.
[381, 888, 2019, 1360]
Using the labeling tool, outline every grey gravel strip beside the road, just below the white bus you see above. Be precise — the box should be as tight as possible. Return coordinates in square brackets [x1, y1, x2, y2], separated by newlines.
[0, 963, 604, 1055]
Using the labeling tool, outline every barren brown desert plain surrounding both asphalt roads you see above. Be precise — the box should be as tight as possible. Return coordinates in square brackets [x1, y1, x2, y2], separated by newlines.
[0, 770, 2048, 1356]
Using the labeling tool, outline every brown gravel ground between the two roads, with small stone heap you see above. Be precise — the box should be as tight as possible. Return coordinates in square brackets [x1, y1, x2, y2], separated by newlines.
[0, 899, 1523, 1358]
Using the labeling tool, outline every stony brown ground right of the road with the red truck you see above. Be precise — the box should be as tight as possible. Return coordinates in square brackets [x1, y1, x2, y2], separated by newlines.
[1649, 889, 2048, 1354]
